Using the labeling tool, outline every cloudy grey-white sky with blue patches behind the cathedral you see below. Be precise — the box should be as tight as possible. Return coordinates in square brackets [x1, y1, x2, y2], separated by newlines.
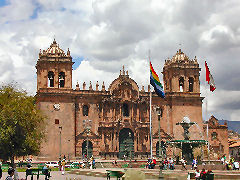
[0, 0, 240, 120]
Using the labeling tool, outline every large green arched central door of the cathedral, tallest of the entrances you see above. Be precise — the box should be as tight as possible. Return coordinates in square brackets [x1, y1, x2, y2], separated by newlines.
[119, 128, 134, 159]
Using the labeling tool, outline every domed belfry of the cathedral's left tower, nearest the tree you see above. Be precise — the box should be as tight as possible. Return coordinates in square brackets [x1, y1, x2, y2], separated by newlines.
[36, 39, 73, 92]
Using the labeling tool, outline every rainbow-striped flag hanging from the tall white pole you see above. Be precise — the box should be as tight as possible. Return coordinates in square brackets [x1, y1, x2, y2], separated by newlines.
[150, 61, 165, 98]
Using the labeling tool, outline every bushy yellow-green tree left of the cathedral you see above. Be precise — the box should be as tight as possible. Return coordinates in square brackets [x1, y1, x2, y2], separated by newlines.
[0, 84, 45, 166]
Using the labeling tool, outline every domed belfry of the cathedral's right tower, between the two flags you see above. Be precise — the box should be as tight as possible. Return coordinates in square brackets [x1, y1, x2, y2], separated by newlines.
[163, 49, 201, 96]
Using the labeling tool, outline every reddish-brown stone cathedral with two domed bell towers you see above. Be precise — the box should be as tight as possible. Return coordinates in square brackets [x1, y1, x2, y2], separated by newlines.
[36, 40, 228, 160]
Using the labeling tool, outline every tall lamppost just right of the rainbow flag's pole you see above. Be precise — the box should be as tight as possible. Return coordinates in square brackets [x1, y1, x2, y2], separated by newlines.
[156, 107, 163, 179]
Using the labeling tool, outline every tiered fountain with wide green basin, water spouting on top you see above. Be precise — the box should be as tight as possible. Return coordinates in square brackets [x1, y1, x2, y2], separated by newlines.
[168, 116, 207, 162]
